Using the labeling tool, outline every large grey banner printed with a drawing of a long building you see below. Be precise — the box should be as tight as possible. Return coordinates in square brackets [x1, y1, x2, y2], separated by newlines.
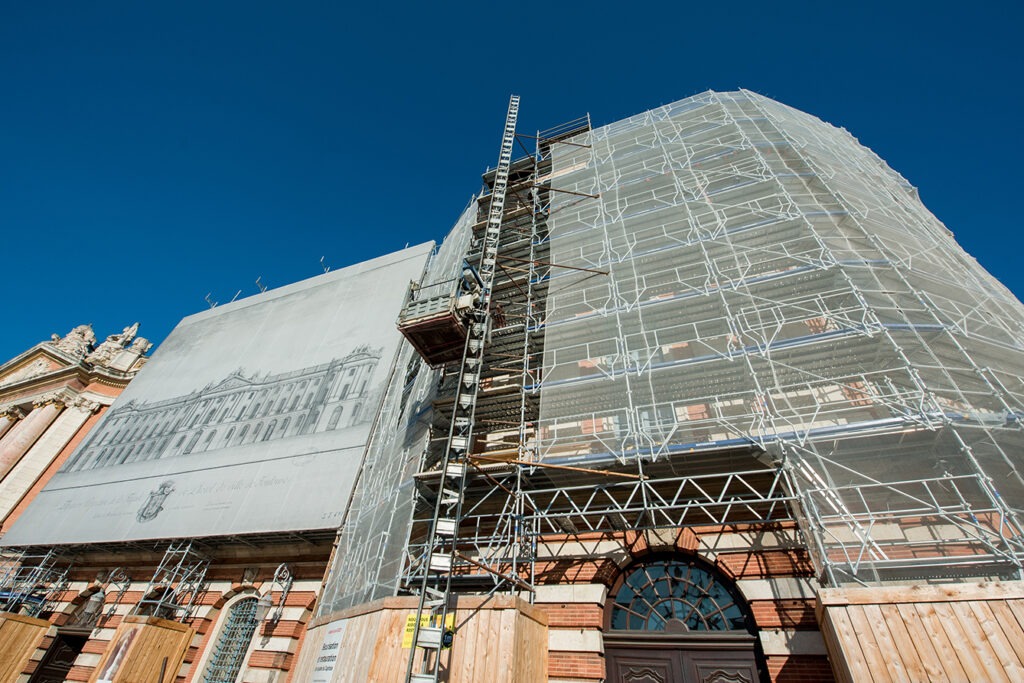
[4, 243, 433, 546]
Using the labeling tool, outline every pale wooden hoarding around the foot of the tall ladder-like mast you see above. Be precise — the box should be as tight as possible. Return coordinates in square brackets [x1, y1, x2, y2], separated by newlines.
[292, 596, 548, 683]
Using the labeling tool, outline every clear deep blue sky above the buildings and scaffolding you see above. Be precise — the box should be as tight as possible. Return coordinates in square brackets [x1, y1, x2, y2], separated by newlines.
[0, 0, 1024, 359]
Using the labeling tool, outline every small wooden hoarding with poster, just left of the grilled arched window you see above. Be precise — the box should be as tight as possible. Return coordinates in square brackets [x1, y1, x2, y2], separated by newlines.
[89, 616, 196, 683]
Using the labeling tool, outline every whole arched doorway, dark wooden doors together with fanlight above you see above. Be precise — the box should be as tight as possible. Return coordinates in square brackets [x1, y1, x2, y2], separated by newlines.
[604, 556, 767, 683]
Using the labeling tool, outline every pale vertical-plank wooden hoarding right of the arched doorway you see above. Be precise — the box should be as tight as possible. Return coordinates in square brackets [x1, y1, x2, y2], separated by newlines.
[817, 582, 1024, 683]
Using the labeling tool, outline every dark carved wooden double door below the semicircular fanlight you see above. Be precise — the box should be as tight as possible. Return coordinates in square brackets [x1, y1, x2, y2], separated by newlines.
[604, 632, 762, 683]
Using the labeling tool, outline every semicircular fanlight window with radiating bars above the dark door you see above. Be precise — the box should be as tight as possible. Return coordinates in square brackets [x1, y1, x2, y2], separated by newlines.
[611, 560, 746, 631]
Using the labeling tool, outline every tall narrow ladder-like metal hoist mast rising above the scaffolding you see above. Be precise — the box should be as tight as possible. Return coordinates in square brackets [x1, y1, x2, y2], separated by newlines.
[406, 95, 519, 683]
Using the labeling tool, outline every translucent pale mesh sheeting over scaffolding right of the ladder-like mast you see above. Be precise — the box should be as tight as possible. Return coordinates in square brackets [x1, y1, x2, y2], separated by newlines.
[538, 91, 1024, 585]
